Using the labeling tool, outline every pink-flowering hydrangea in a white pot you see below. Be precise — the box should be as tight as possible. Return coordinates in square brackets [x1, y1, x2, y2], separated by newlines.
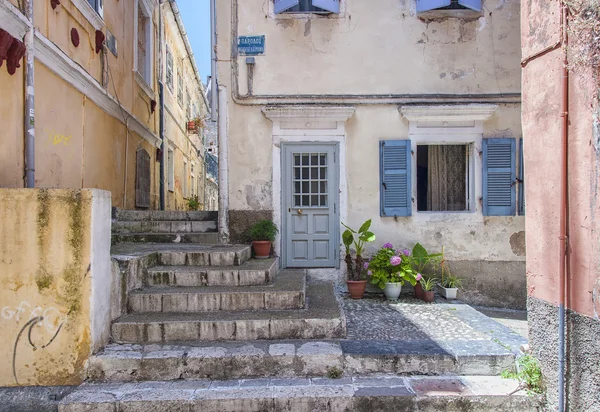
[368, 243, 421, 300]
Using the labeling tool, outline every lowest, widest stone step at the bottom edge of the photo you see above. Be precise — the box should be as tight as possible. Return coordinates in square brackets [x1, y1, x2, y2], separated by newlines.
[58, 376, 541, 412]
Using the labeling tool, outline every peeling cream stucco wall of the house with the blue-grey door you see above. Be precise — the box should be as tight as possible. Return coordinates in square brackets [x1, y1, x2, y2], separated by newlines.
[217, 0, 525, 264]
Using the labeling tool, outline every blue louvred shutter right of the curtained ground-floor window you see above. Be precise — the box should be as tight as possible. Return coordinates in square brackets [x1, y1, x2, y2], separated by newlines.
[483, 138, 517, 216]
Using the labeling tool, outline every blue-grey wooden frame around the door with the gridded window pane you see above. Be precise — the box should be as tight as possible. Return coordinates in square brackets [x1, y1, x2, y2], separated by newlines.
[279, 141, 341, 269]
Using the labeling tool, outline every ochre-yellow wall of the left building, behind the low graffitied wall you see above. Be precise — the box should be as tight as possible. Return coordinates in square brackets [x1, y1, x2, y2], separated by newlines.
[0, 0, 196, 209]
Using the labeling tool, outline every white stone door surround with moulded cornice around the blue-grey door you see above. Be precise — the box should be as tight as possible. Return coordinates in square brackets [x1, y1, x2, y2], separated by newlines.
[261, 105, 356, 269]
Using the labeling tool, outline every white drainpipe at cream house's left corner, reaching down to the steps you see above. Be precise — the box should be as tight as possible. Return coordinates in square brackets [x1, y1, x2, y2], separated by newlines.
[219, 86, 229, 244]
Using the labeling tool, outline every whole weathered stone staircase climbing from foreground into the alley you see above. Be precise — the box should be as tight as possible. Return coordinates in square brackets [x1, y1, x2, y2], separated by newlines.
[59, 211, 538, 412]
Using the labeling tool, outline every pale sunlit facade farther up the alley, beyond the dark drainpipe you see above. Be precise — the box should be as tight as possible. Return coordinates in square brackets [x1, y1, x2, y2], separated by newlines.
[164, 2, 208, 210]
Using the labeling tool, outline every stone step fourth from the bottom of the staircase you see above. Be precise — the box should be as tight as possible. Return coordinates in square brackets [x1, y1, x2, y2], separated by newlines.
[127, 271, 305, 313]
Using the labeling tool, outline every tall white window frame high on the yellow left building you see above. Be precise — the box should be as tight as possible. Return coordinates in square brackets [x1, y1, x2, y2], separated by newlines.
[133, 0, 154, 98]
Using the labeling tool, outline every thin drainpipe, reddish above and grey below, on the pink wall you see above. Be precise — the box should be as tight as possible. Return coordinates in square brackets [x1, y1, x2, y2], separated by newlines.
[558, 1, 569, 412]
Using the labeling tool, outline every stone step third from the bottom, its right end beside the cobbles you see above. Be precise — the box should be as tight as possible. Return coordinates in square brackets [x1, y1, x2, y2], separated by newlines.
[112, 280, 346, 343]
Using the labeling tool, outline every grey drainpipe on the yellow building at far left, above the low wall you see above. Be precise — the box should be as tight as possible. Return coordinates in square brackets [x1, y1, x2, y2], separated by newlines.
[24, 0, 35, 188]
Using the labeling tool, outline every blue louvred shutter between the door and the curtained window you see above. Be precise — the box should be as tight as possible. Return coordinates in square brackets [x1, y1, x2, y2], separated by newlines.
[379, 140, 412, 216]
